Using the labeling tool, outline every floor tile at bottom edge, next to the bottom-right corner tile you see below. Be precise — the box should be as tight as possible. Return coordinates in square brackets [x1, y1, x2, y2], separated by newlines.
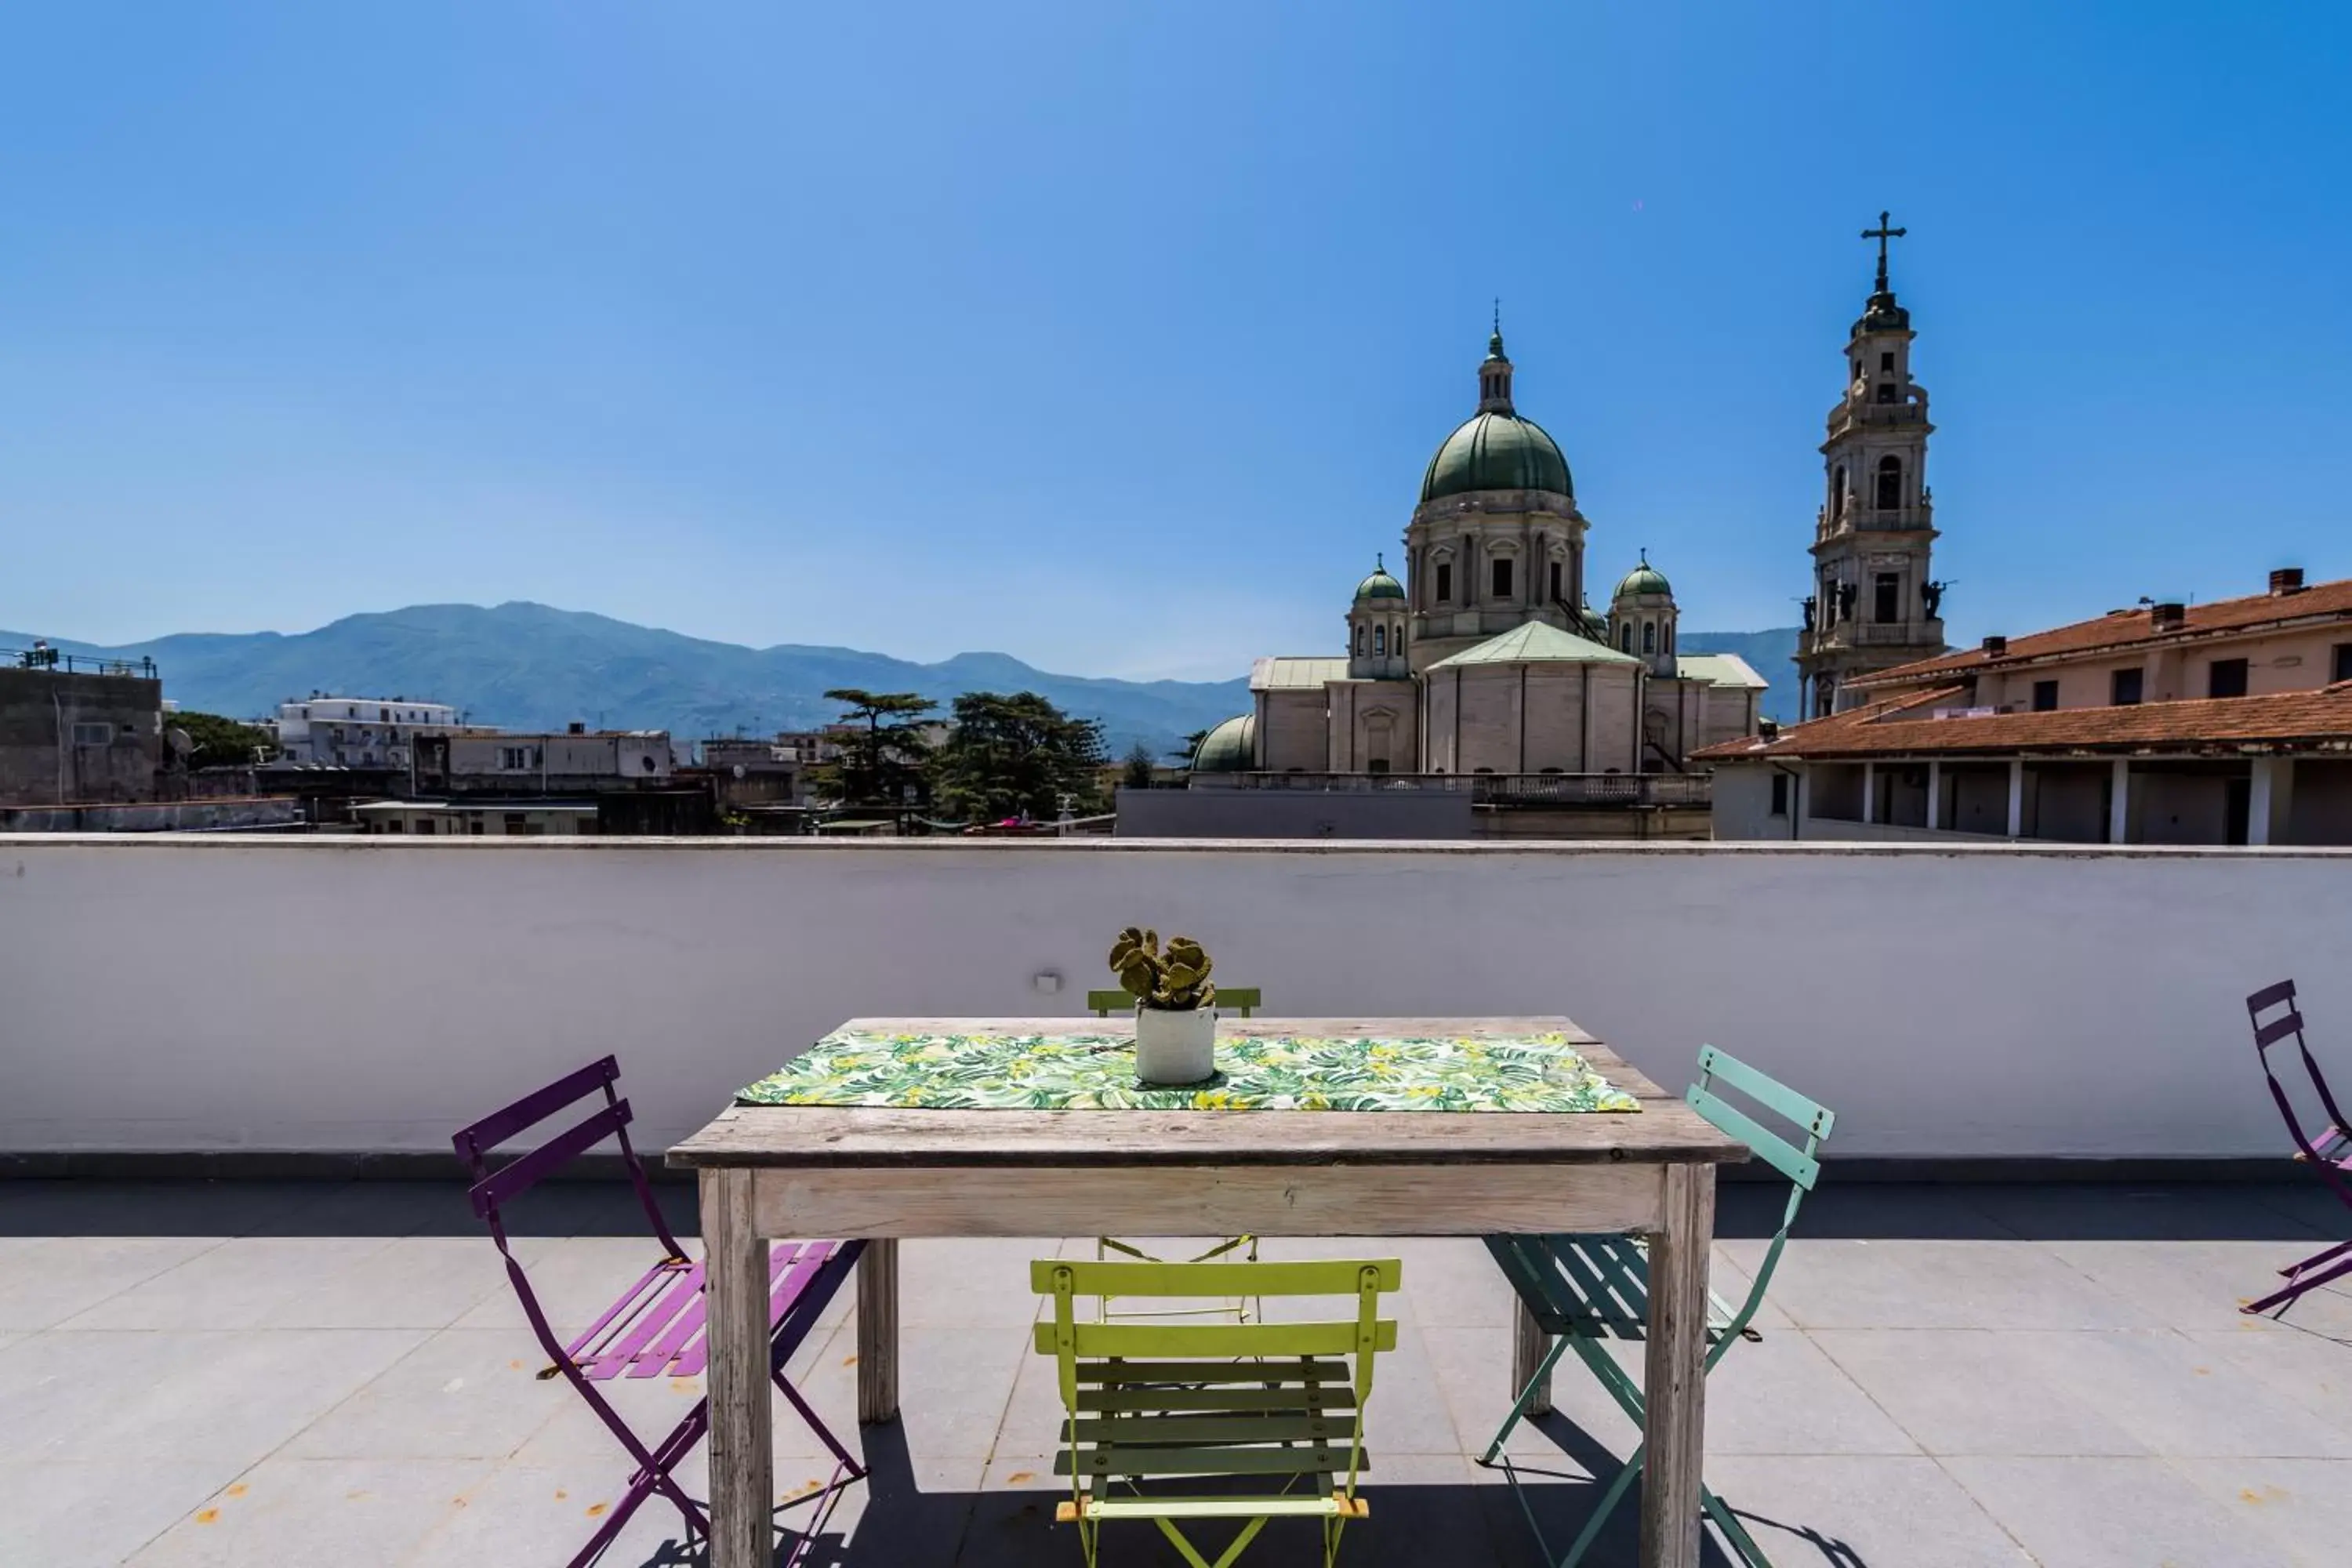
[1943, 1455, 2296, 1568]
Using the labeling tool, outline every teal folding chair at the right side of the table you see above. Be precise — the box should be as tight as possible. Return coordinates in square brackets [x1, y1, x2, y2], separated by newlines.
[1479, 1046, 1835, 1568]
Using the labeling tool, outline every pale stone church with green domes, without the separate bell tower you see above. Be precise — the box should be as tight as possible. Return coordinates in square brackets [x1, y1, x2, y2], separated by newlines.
[1192, 325, 1764, 774]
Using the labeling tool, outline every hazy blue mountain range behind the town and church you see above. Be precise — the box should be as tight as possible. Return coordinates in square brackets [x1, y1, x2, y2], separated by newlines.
[0, 602, 1795, 755]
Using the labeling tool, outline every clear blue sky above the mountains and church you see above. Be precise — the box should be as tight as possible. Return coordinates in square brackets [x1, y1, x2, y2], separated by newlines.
[0, 0, 2352, 682]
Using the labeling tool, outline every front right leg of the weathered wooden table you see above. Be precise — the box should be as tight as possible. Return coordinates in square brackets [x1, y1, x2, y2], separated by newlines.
[1642, 1166, 1715, 1568]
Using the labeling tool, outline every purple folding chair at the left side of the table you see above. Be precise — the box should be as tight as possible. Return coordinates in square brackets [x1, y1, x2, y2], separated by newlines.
[452, 1055, 866, 1568]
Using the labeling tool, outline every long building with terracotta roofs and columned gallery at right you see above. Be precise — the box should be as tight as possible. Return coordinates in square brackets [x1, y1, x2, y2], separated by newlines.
[1698, 569, 2352, 844]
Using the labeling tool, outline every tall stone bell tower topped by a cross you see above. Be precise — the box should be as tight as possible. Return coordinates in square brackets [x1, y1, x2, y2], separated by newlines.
[1797, 212, 1945, 720]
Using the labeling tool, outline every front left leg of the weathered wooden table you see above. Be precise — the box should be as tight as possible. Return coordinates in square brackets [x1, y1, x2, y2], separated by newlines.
[703, 1168, 776, 1568]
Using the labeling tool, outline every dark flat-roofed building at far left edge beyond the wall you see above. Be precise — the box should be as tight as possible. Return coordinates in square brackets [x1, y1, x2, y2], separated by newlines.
[0, 642, 165, 806]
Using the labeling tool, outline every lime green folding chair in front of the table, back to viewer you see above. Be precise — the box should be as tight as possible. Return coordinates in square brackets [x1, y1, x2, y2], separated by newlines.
[1030, 1258, 1404, 1568]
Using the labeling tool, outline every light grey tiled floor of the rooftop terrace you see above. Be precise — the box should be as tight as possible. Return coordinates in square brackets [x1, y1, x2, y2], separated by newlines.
[0, 1182, 2352, 1568]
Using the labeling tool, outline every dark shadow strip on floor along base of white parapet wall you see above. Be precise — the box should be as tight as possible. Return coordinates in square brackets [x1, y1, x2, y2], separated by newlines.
[0, 1161, 2345, 1241]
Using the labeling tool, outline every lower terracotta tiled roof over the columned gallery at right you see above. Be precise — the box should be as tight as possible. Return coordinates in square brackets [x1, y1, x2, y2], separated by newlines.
[1691, 682, 2352, 762]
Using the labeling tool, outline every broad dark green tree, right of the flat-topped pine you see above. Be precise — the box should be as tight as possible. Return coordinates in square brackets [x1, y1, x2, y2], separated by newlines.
[931, 691, 1103, 822]
